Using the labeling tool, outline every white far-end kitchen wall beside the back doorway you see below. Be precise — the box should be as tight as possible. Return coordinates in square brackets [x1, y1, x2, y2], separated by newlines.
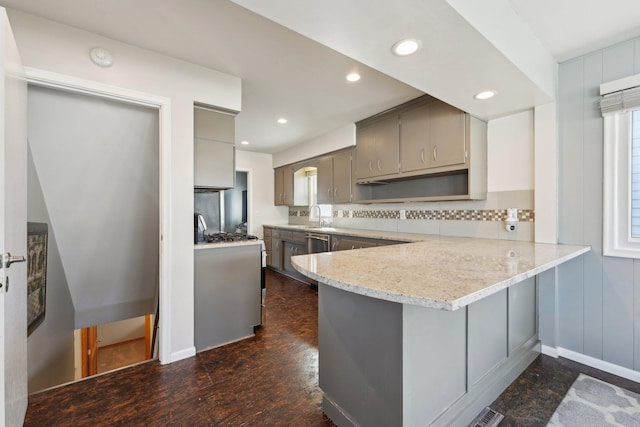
[236, 150, 289, 238]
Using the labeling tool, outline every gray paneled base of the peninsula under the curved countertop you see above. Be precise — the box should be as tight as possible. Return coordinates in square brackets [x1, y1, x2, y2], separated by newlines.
[318, 277, 540, 427]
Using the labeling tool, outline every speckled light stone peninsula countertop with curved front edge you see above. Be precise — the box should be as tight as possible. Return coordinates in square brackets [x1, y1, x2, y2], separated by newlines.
[291, 235, 591, 311]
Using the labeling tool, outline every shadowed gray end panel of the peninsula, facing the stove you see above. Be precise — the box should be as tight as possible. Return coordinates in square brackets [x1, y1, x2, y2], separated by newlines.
[318, 284, 403, 427]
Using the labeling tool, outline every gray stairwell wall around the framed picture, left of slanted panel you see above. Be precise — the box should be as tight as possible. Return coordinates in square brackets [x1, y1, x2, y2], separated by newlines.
[27, 145, 75, 393]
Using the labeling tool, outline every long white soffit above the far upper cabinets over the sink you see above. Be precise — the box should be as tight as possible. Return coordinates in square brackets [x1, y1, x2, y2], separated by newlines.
[273, 123, 356, 168]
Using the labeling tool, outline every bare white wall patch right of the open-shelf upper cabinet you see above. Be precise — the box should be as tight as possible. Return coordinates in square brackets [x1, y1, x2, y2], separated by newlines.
[487, 110, 534, 192]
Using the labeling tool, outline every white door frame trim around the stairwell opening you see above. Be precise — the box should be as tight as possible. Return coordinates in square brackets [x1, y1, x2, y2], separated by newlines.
[24, 67, 172, 364]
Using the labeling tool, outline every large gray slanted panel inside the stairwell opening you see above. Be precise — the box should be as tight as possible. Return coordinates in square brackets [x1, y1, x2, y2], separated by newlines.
[28, 86, 159, 328]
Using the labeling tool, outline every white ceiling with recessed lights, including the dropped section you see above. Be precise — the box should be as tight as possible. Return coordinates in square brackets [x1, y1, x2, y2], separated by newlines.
[0, 0, 640, 153]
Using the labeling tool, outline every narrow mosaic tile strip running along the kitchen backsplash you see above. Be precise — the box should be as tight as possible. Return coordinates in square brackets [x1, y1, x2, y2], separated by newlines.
[289, 207, 535, 222]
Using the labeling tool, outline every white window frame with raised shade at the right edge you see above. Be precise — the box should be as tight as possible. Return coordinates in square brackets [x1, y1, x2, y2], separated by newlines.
[600, 74, 640, 259]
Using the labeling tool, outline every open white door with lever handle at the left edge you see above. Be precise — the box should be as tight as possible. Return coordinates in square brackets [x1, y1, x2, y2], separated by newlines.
[0, 8, 27, 427]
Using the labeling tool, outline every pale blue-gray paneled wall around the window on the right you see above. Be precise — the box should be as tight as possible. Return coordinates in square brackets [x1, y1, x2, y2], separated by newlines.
[556, 38, 640, 370]
